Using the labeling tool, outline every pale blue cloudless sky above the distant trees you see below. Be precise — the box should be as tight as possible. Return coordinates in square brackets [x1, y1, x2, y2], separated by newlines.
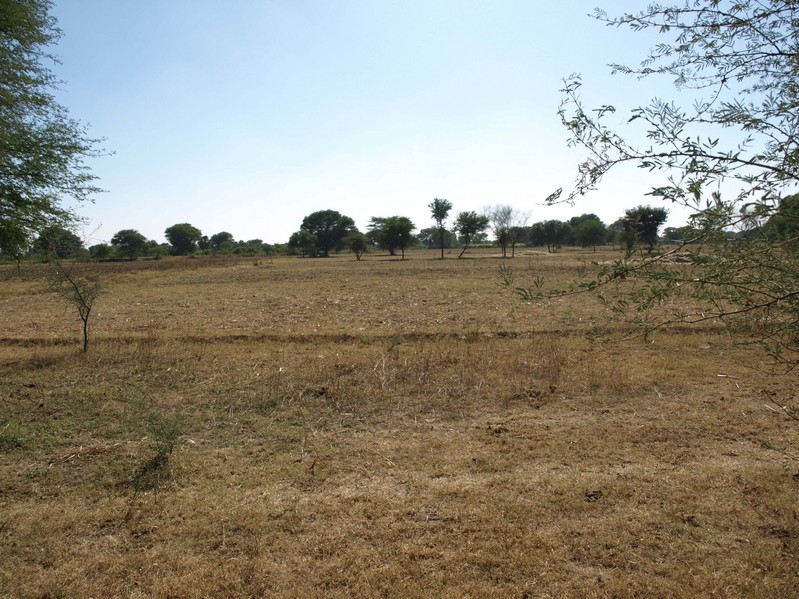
[48, 0, 684, 244]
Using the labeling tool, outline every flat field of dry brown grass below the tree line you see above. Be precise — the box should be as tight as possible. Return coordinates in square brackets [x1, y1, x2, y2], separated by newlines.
[0, 247, 799, 599]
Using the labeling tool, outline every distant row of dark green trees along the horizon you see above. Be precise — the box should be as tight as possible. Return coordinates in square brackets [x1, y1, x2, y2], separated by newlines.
[27, 194, 799, 260]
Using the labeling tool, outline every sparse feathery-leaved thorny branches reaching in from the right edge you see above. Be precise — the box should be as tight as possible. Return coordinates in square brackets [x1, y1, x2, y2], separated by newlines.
[549, 0, 799, 365]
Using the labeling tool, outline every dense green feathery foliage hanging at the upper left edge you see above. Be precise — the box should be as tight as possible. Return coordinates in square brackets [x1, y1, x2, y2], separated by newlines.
[0, 0, 100, 260]
